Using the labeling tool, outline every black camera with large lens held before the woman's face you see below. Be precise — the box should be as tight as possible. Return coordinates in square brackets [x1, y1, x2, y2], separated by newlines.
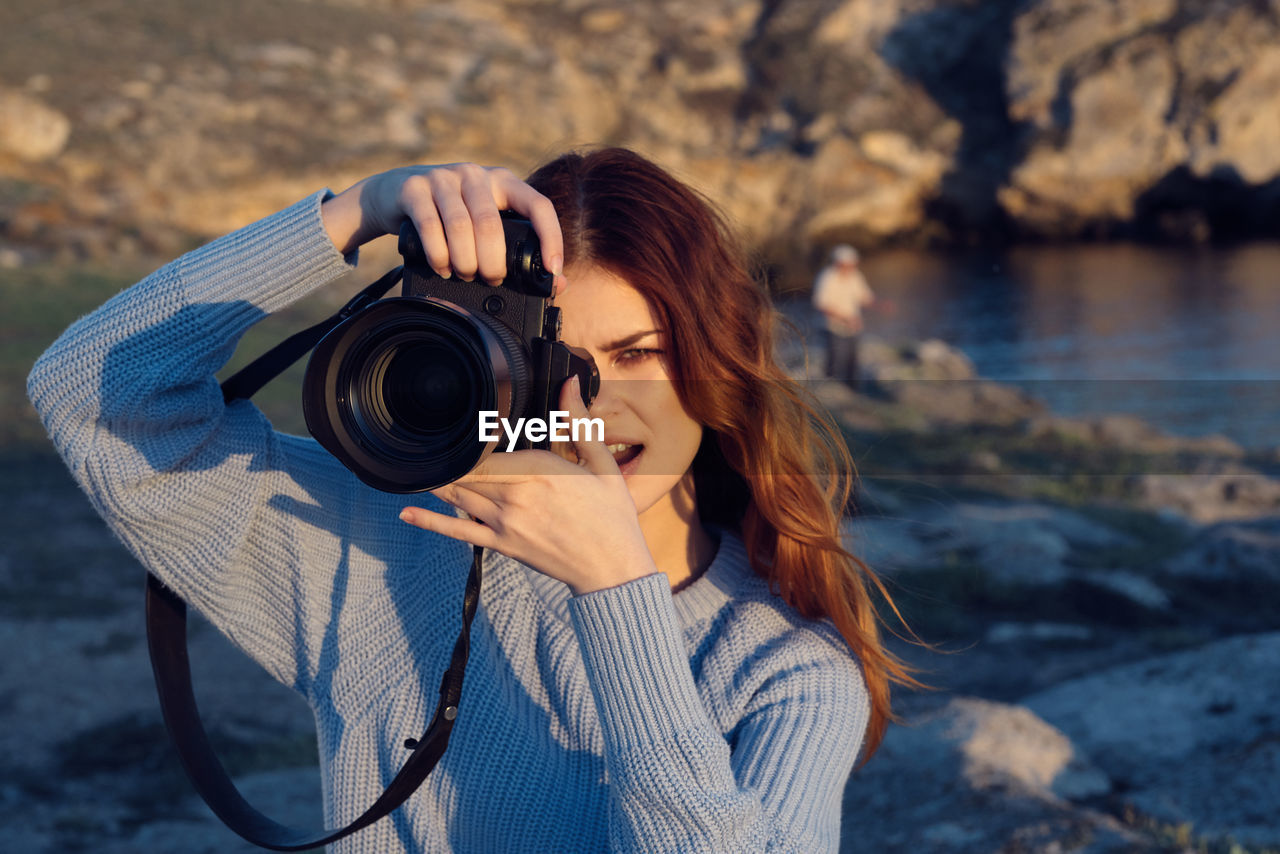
[302, 213, 600, 493]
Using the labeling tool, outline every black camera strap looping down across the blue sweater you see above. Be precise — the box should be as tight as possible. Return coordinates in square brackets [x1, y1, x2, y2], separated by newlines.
[146, 268, 484, 851]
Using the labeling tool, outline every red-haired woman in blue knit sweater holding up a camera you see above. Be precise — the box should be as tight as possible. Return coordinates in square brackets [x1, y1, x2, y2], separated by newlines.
[29, 150, 910, 853]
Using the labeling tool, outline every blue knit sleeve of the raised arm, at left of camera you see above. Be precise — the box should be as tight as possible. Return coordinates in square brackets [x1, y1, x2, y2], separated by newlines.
[28, 193, 414, 693]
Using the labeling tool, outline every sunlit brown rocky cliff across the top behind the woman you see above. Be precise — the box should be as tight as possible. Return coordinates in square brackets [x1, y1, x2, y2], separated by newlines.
[0, 0, 1280, 278]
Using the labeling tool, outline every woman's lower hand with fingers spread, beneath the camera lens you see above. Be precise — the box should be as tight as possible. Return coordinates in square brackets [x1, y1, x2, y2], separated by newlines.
[401, 376, 658, 594]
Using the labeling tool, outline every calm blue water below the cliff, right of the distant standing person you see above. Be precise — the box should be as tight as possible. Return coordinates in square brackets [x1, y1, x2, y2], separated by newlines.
[844, 243, 1280, 448]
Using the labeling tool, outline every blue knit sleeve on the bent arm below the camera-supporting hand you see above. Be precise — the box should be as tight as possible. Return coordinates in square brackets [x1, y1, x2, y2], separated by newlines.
[571, 575, 869, 853]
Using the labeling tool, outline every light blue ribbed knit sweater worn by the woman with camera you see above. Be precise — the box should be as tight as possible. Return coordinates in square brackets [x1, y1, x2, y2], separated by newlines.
[28, 193, 869, 854]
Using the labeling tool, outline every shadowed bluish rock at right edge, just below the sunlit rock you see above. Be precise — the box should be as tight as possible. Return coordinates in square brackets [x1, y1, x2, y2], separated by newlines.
[1164, 517, 1280, 585]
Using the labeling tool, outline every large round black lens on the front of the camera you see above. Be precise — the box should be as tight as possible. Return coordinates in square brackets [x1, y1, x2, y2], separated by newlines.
[302, 297, 531, 493]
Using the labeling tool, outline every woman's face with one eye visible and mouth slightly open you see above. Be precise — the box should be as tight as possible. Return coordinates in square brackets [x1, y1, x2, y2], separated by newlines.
[556, 264, 703, 515]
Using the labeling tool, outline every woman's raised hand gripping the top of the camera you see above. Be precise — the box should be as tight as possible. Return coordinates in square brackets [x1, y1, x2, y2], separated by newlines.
[321, 163, 564, 293]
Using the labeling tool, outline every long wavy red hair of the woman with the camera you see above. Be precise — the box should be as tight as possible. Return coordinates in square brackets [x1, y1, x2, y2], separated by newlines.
[529, 149, 918, 762]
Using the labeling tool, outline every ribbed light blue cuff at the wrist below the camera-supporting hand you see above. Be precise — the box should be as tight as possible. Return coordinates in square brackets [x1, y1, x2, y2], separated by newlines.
[570, 572, 709, 746]
